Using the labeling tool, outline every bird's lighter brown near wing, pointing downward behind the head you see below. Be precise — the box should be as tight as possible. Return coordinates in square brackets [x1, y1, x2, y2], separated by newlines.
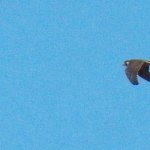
[125, 61, 144, 85]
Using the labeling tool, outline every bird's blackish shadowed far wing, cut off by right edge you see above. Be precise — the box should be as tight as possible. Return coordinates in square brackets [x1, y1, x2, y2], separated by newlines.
[138, 63, 150, 82]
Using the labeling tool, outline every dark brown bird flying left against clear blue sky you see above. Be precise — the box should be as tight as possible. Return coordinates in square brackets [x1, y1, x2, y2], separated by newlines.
[123, 59, 150, 85]
